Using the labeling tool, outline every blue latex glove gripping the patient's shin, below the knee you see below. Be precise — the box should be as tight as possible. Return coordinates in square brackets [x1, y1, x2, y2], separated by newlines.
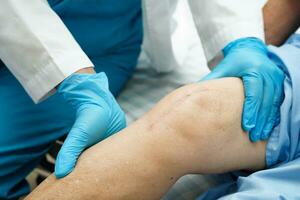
[55, 73, 126, 178]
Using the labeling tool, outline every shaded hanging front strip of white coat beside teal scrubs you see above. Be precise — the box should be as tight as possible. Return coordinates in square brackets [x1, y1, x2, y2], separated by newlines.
[142, 0, 178, 72]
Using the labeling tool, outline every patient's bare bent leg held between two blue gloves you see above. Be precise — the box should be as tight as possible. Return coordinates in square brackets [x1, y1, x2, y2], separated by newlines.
[28, 78, 265, 200]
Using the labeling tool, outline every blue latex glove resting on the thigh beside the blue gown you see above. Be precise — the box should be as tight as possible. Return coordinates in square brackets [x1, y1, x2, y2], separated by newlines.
[203, 38, 284, 142]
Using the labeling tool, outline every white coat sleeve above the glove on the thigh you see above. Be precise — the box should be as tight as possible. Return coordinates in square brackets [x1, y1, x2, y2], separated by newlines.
[189, 0, 266, 62]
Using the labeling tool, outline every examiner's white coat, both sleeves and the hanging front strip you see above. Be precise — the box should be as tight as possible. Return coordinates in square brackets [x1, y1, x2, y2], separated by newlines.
[0, 0, 265, 102]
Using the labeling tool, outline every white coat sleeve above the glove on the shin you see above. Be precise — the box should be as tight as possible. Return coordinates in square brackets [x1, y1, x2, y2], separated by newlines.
[0, 0, 93, 102]
